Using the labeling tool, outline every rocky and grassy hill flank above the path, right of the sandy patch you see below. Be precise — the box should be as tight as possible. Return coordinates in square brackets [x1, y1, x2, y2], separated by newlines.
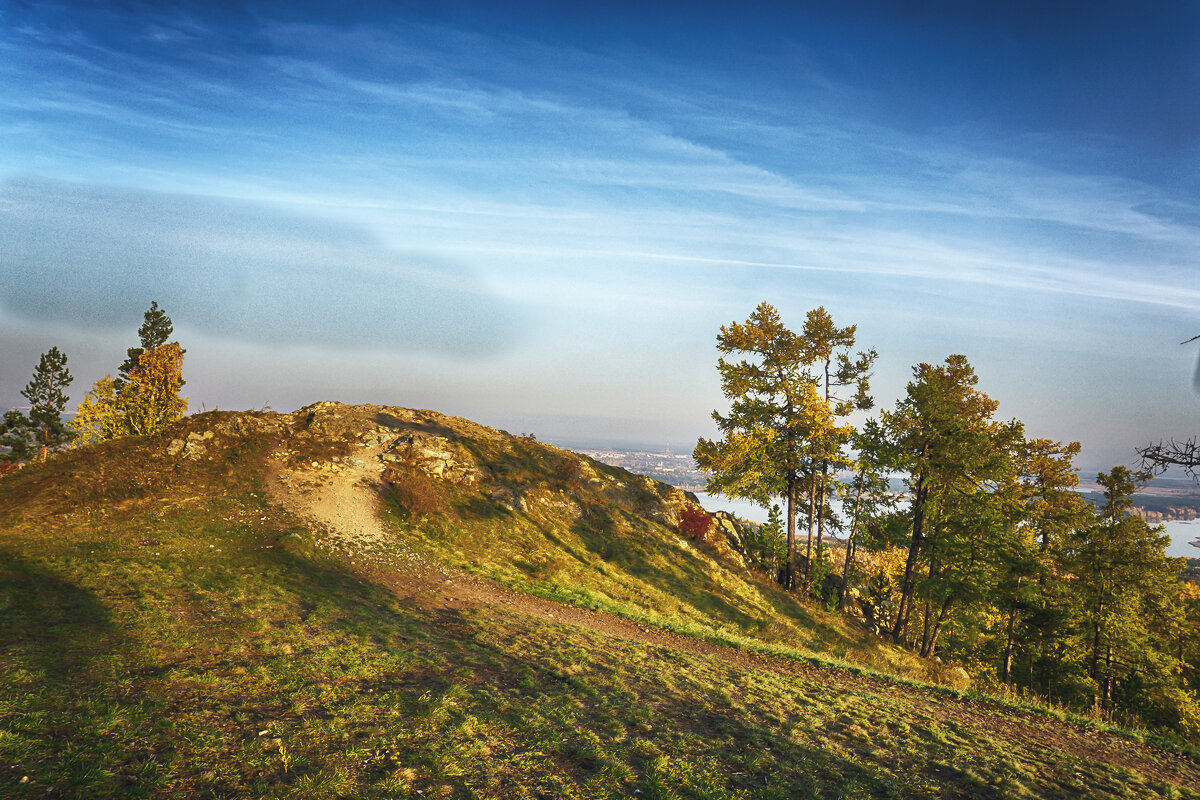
[274, 404, 920, 672]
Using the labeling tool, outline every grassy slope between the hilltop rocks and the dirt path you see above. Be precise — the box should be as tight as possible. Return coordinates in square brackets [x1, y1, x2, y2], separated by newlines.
[386, 476, 930, 679]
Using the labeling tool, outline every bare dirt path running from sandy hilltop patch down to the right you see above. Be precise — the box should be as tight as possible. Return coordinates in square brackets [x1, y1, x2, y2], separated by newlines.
[268, 449, 1200, 792]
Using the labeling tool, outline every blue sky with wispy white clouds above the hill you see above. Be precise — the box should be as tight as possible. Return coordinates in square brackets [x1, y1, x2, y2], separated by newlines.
[0, 0, 1200, 469]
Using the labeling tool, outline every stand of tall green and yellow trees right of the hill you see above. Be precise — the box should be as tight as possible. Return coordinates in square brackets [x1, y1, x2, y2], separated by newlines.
[695, 303, 1200, 740]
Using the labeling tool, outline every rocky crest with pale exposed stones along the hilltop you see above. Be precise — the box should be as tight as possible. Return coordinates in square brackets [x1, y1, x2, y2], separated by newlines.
[156, 402, 745, 575]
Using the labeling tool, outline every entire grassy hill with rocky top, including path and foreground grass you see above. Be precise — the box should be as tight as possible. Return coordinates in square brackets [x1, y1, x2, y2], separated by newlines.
[0, 404, 1200, 798]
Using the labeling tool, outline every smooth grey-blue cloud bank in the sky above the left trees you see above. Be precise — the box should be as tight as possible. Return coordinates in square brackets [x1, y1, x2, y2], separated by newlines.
[0, 180, 521, 357]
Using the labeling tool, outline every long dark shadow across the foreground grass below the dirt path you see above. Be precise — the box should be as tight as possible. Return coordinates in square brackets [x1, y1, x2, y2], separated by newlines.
[258, 554, 1000, 798]
